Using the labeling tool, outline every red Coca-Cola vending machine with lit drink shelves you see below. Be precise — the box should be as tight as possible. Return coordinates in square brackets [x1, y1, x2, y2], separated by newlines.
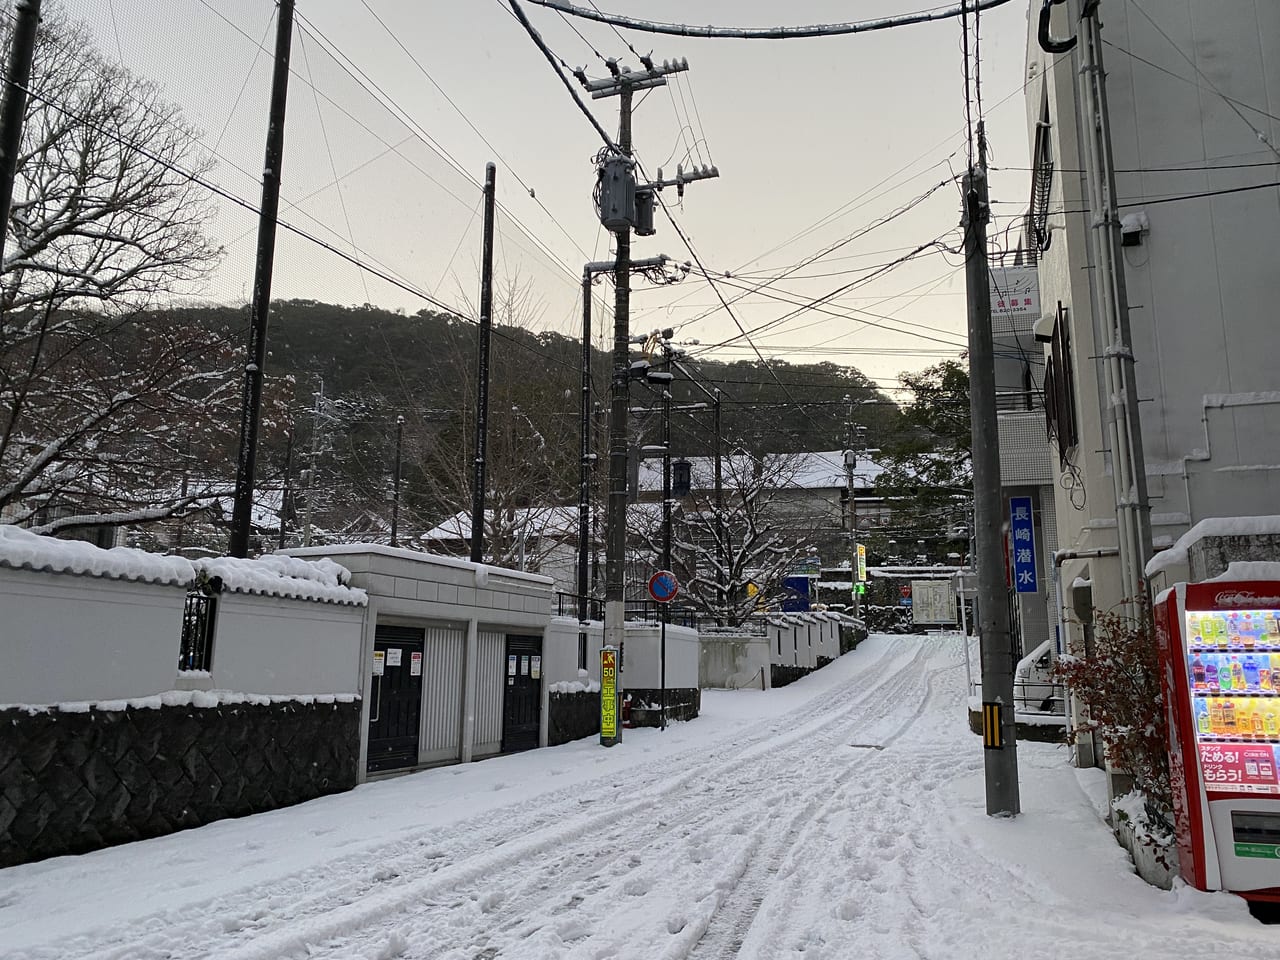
[1155, 580, 1280, 901]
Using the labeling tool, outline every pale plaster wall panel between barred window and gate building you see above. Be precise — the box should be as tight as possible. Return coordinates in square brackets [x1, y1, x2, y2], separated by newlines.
[210, 593, 365, 694]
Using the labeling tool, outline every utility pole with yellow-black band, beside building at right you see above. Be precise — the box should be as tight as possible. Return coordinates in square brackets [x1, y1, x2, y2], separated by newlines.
[964, 122, 1020, 817]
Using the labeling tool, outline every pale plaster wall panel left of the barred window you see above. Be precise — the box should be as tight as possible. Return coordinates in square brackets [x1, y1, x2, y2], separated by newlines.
[0, 568, 187, 704]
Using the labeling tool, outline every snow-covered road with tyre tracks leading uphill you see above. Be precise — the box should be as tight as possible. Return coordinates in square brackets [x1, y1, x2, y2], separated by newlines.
[0, 636, 1280, 960]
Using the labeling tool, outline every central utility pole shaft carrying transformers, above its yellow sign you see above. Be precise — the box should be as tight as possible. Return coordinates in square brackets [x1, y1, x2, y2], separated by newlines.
[604, 84, 631, 687]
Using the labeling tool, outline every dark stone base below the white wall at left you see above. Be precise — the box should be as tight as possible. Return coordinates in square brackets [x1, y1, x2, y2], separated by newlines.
[0, 700, 360, 867]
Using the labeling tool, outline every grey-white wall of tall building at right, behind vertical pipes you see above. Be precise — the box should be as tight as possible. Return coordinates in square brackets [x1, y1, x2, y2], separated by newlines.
[1027, 0, 1280, 608]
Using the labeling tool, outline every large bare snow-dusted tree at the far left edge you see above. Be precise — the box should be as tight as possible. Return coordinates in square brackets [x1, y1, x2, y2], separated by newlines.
[0, 8, 247, 532]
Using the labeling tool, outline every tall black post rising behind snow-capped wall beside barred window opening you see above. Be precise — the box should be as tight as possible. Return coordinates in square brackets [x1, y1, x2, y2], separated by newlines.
[228, 0, 293, 557]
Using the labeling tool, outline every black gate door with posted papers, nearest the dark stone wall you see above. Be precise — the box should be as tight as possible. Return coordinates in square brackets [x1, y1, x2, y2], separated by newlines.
[367, 626, 422, 773]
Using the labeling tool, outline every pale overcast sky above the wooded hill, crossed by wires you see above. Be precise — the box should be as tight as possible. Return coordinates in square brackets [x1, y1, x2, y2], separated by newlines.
[65, 0, 1028, 387]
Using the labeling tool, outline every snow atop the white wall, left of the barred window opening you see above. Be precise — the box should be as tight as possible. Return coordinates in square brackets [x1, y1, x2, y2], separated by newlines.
[0, 524, 196, 586]
